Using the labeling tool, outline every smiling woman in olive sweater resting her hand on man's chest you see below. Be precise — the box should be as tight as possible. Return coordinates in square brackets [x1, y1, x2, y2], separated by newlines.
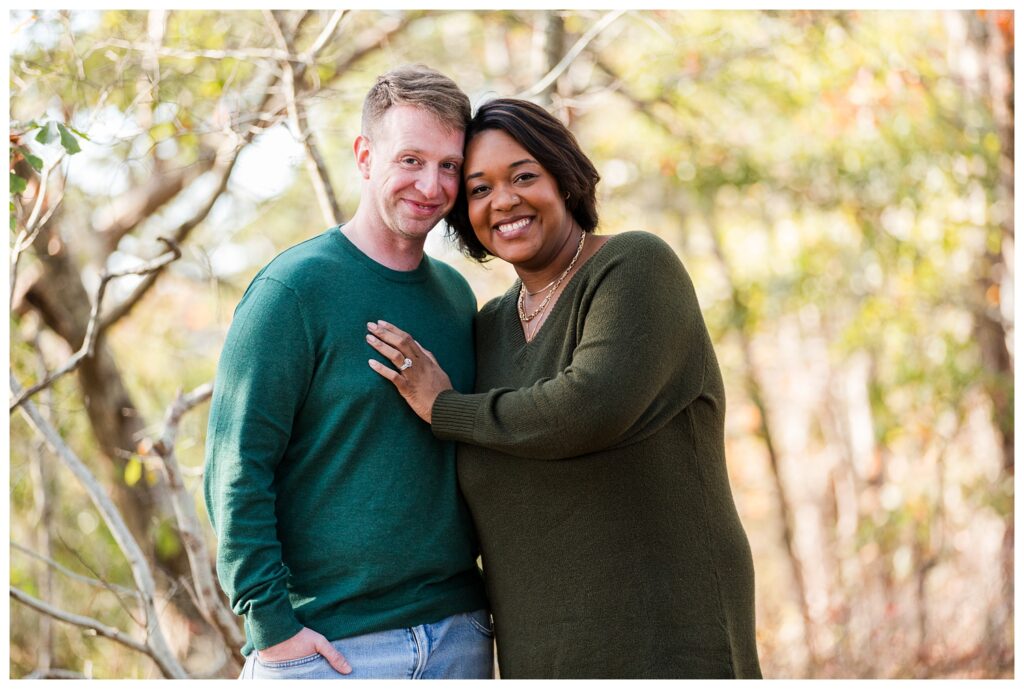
[368, 99, 761, 678]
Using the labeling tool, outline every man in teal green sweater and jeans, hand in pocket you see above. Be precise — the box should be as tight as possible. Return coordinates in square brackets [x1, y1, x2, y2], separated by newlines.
[204, 66, 493, 679]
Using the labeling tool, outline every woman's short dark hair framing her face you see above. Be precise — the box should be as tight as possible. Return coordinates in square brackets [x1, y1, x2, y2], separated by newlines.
[444, 98, 601, 262]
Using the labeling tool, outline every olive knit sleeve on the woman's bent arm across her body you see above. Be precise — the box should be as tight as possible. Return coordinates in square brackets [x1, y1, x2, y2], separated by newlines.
[432, 233, 710, 460]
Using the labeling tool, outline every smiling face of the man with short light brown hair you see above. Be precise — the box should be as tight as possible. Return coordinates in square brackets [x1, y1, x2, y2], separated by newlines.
[355, 105, 465, 240]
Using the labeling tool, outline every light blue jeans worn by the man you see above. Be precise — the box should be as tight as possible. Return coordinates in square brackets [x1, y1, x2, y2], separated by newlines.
[239, 610, 495, 680]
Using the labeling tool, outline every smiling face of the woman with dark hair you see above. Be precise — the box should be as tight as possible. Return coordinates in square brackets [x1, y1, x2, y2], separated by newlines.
[463, 129, 575, 270]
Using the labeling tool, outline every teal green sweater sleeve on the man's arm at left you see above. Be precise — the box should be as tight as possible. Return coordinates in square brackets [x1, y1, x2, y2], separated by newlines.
[203, 277, 313, 649]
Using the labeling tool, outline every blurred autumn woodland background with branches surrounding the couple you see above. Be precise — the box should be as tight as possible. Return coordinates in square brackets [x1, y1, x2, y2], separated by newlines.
[8, 10, 1014, 678]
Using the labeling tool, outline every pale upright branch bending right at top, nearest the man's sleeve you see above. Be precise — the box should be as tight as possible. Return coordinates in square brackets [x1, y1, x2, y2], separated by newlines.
[144, 383, 245, 648]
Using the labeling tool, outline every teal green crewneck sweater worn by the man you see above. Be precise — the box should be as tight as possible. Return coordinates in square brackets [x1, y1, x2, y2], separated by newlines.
[204, 227, 486, 653]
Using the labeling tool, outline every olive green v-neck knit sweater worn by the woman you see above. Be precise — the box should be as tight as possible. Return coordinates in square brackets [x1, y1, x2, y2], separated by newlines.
[432, 232, 761, 678]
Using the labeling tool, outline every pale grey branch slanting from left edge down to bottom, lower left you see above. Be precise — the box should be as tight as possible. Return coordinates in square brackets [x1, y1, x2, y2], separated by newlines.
[10, 373, 187, 679]
